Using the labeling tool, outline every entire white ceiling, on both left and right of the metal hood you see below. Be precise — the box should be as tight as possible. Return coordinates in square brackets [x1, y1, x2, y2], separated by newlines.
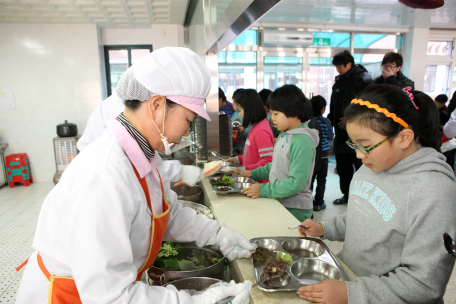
[0, 0, 456, 29]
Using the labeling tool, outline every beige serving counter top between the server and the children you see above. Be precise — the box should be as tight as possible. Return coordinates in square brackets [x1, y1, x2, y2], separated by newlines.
[200, 178, 356, 304]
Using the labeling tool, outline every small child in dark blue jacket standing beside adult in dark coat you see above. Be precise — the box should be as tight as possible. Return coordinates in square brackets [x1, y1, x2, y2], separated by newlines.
[310, 95, 334, 211]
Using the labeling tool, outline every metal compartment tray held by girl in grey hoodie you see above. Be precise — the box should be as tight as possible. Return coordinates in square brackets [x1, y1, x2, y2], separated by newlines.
[250, 237, 348, 292]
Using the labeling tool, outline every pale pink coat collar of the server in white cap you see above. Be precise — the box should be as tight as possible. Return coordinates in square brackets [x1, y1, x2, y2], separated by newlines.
[107, 117, 159, 178]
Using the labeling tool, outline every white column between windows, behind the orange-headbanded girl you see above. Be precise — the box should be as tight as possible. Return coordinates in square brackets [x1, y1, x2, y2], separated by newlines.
[401, 27, 429, 91]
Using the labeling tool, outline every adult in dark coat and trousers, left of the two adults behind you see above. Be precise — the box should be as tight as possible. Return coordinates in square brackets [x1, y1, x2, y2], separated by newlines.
[328, 51, 374, 204]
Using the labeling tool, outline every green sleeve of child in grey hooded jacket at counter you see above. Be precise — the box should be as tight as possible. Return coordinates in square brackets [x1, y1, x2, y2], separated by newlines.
[260, 134, 315, 199]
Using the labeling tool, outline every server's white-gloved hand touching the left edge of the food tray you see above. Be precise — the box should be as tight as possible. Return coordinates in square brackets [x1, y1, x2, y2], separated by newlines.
[215, 227, 257, 261]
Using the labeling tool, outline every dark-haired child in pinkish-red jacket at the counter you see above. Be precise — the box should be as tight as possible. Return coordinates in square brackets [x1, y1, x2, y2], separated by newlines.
[227, 89, 274, 183]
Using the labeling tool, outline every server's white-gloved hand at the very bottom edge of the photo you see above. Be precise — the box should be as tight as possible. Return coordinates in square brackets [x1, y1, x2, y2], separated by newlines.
[192, 281, 253, 304]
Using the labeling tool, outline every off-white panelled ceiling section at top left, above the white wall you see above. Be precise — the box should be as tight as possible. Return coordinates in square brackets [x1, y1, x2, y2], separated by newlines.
[0, 0, 189, 28]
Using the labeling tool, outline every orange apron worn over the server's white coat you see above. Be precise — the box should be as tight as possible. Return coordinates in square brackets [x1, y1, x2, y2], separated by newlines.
[16, 164, 169, 304]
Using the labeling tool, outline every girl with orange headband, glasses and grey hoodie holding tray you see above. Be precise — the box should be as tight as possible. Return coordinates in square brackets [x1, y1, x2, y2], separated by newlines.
[297, 85, 456, 303]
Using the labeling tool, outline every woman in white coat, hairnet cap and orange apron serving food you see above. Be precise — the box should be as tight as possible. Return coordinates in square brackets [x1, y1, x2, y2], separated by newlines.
[16, 48, 255, 304]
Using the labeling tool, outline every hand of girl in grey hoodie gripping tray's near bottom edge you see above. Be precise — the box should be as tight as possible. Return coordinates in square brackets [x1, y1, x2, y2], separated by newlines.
[296, 279, 348, 304]
